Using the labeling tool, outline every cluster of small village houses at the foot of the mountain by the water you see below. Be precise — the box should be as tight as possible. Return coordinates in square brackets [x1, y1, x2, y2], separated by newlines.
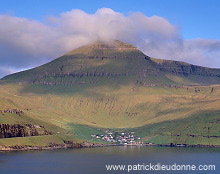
[91, 131, 143, 145]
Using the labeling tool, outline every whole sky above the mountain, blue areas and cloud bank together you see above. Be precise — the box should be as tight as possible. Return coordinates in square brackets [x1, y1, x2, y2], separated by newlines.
[0, 0, 220, 78]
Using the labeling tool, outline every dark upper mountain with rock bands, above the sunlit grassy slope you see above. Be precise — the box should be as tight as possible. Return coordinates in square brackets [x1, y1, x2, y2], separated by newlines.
[3, 41, 220, 86]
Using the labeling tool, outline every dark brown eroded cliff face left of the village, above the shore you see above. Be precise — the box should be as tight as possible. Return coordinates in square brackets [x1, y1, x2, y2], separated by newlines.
[0, 123, 51, 138]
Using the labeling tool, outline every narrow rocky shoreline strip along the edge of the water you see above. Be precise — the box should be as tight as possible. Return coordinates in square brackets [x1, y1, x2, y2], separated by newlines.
[0, 141, 220, 153]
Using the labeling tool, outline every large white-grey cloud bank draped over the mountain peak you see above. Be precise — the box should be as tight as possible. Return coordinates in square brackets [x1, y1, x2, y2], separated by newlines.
[0, 8, 220, 76]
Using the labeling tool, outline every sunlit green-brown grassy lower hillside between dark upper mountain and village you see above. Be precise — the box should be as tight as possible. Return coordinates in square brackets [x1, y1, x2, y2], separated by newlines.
[0, 82, 220, 144]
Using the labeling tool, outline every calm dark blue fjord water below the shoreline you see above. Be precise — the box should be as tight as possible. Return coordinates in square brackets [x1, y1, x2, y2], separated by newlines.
[0, 146, 220, 174]
